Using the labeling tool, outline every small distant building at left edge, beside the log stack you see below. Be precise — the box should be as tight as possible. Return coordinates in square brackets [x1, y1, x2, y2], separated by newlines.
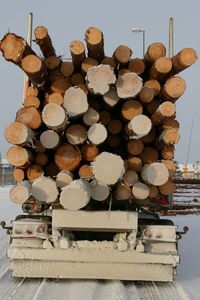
[0, 158, 14, 186]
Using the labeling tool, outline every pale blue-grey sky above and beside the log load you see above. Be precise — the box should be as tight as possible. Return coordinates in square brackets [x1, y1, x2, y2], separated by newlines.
[0, 0, 200, 162]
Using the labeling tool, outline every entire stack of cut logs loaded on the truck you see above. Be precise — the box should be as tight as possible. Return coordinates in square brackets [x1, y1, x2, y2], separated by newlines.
[0, 26, 197, 210]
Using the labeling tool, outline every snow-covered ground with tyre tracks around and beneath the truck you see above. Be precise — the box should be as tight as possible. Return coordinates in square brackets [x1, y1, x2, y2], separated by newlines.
[0, 188, 200, 300]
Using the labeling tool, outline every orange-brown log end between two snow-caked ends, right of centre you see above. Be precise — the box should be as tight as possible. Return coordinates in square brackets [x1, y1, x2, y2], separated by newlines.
[121, 100, 143, 121]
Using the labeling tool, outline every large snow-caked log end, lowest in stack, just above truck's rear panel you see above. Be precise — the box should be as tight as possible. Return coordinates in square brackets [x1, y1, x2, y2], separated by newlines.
[60, 179, 92, 210]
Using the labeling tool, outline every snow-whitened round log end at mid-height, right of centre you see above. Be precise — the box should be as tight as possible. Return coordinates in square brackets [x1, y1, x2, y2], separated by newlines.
[128, 115, 152, 139]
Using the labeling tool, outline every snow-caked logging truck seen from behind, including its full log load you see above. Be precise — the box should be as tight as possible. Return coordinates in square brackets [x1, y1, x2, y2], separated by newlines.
[0, 17, 197, 281]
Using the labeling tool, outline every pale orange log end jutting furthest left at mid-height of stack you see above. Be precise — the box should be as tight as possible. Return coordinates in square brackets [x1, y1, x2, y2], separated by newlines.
[4, 122, 35, 146]
